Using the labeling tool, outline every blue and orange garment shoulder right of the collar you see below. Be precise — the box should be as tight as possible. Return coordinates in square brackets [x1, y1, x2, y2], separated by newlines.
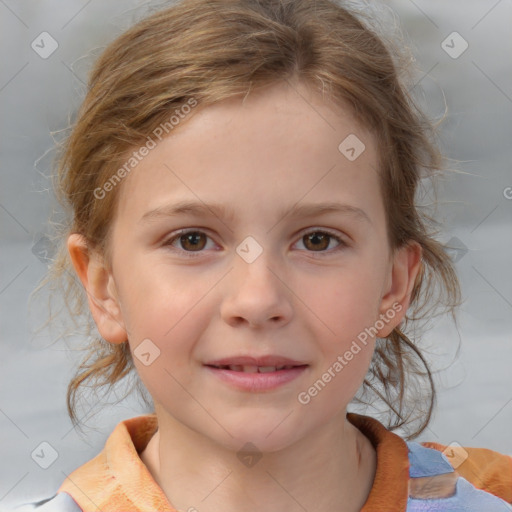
[407, 442, 512, 512]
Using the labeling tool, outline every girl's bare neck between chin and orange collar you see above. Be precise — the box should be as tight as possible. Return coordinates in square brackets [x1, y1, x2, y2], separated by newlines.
[141, 410, 376, 512]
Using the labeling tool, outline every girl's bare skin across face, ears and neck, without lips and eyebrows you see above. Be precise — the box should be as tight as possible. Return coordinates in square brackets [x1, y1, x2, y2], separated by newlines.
[68, 83, 421, 512]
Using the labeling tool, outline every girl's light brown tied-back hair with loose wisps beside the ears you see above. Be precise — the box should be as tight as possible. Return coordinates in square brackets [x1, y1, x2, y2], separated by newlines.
[44, 0, 460, 438]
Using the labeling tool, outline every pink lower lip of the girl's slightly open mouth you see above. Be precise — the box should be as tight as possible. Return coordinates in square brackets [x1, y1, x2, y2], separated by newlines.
[205, 366, 308, 391]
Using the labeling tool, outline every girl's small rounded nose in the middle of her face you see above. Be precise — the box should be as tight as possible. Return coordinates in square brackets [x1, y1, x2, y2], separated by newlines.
[221, 251, 293, 328]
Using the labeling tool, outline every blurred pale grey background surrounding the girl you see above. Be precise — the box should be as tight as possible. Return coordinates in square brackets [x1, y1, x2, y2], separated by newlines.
[0, 0, 512, 510]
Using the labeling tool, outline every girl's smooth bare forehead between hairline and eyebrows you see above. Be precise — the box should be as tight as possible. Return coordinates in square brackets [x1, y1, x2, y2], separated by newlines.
[114, 79, 382, 222]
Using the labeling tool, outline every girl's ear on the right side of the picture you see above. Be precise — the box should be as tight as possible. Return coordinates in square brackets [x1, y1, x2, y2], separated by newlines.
[377, 242, 422, 338]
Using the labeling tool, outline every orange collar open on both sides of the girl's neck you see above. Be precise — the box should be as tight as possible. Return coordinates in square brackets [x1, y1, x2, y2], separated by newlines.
[58, 413, 409, 512]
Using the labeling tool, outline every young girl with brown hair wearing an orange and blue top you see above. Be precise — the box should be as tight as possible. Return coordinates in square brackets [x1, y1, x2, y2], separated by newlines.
[18, 0, 512, 512]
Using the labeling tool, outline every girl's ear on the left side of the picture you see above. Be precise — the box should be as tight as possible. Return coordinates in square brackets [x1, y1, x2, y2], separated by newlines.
[67, 233, 128, 343]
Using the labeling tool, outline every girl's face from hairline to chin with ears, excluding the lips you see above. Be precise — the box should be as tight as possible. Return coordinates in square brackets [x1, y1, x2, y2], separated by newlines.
[77, 80, 419, 451]
